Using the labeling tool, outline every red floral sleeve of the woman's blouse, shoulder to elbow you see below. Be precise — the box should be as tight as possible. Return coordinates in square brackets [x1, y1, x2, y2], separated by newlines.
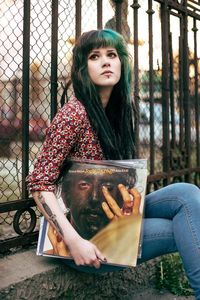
[27, 102, 86, 192]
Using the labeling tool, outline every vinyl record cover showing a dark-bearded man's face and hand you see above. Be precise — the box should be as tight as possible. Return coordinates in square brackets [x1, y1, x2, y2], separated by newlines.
[37, 159, 147, 266]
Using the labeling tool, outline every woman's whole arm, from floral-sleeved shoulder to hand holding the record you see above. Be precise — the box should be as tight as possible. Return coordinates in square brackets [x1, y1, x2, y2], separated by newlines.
[27, 103, 103, 268]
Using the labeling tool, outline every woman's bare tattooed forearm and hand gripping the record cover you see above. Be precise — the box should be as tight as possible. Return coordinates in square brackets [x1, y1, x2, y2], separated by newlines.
[32, 191, 105, 268]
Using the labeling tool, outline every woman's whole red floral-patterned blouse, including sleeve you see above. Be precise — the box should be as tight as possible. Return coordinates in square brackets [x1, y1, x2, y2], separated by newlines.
[27, 98, 104, 192]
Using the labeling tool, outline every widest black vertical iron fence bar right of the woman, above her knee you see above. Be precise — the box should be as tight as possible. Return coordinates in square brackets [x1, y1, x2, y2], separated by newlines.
[161, 1, 170, 184]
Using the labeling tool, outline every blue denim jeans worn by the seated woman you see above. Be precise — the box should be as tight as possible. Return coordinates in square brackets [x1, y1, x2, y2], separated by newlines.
[65, 183, 200, 300]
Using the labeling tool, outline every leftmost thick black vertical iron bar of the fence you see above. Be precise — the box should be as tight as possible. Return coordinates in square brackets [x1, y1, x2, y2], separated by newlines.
[22, 0, 31, 198]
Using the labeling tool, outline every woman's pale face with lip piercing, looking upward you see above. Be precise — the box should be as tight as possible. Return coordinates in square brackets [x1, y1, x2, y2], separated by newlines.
[88, 47, 121, 90]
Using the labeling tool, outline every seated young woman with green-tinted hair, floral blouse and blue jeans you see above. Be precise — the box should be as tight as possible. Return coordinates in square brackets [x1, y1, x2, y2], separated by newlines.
[28, 29, 200, 299]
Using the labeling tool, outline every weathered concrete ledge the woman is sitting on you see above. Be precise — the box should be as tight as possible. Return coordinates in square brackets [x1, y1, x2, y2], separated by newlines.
[0, 249, 159, 300]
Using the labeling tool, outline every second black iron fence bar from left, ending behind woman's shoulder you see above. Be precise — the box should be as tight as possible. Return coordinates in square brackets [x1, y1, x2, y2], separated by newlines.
[51, 0, 58, 120]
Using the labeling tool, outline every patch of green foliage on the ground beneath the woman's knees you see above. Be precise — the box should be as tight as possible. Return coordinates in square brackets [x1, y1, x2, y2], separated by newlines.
[156, 254, 193, 296]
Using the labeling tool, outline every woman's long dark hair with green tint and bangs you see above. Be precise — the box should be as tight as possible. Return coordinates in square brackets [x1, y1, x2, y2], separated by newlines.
[71, 29, 134, 159]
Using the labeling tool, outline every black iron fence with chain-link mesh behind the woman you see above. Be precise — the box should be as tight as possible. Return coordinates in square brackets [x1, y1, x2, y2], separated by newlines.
[0, 0, 200, 252]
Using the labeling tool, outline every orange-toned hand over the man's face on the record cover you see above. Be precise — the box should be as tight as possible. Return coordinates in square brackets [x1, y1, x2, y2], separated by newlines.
[102, 184, 141, 220]
